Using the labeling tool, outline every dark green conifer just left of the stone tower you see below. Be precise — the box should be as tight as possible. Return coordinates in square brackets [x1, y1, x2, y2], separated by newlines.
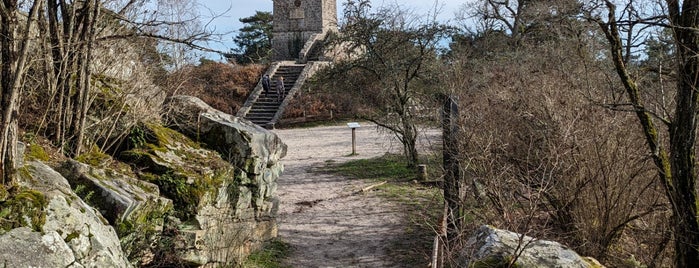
[227, 11, 272, 64]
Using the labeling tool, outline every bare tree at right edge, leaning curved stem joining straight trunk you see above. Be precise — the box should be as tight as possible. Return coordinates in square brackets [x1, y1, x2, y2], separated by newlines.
[595, 0, 699, 267]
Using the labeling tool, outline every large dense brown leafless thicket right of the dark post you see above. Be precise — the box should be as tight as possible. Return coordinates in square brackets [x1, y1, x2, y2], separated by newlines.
[448, 38, 669, 266]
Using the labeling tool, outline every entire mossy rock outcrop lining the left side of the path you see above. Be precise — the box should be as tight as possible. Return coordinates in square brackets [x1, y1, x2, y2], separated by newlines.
[0, 97, 286, 267]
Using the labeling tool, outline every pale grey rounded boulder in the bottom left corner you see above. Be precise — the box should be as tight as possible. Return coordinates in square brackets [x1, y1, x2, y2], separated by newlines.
[0, 161, 131, 267]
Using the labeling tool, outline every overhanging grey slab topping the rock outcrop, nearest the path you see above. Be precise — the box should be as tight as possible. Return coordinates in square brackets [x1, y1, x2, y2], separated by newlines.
[165, 96, 286, 221]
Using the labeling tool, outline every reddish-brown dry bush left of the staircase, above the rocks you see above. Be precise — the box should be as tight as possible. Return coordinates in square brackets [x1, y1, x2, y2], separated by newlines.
[164, 61, 266, 114]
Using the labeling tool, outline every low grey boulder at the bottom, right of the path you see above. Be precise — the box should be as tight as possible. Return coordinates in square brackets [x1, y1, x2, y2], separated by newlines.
[457, 225, 603, 268]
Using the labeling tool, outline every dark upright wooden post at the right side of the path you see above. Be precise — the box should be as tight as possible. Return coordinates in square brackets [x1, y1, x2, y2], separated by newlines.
[442, 96, 463, 245]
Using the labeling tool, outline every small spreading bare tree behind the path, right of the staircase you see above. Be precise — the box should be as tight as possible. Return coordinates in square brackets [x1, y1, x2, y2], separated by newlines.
[328, 1, 448, 167]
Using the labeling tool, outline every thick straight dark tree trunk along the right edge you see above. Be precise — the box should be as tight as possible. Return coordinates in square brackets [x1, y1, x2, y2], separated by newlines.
[669, 10, 699, 267]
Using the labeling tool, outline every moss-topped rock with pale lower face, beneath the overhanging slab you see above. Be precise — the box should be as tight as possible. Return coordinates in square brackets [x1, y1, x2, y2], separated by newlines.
[121, 122, 281, 266]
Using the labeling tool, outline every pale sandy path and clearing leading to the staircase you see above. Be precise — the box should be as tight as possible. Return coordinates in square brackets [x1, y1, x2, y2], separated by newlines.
[274, 123, 436, 267]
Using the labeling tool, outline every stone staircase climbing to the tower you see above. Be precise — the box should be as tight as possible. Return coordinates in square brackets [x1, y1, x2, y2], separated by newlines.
[238, 63, 306, 127]
